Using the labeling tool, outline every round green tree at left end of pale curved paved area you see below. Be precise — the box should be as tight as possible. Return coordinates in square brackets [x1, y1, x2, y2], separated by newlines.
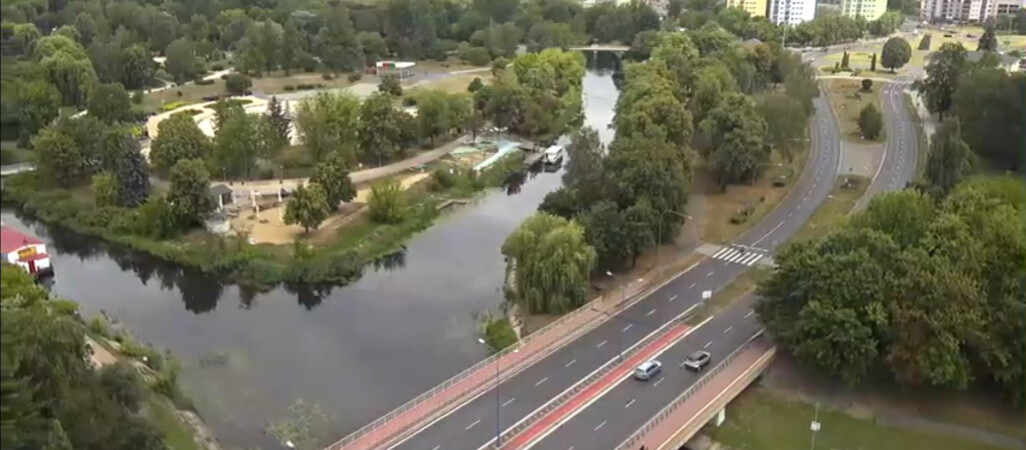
[150, 111, 211, 174]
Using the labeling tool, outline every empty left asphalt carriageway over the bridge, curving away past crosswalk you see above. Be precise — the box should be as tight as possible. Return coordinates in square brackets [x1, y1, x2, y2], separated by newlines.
[392, 90, 839, 450]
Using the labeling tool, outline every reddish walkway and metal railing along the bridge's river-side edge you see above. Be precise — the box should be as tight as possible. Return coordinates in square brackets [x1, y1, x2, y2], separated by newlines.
[326, 282, 652, 450]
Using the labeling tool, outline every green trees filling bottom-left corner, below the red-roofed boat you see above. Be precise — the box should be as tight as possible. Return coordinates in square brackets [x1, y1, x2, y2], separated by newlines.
[0, 263, 167, 450]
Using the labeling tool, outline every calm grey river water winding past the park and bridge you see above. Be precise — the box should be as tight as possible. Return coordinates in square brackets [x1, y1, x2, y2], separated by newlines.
[0, 54, 618, 449]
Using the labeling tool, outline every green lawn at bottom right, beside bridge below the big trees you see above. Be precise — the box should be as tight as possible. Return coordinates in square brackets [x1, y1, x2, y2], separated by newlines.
[705, 386, 1001, 450]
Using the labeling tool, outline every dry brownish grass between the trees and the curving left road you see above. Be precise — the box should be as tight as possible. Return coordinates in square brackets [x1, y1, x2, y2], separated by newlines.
[692, 140, 808, 244]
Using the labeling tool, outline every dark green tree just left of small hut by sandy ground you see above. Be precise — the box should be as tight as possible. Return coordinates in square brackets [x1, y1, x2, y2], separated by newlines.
[167, 159, 214, 229]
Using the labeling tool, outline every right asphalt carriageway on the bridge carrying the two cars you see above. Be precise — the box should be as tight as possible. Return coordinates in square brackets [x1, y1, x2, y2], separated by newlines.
[529, 295, 760, 450]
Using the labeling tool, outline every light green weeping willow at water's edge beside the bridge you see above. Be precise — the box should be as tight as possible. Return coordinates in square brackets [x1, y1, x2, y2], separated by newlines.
[502, 212, 596, 314]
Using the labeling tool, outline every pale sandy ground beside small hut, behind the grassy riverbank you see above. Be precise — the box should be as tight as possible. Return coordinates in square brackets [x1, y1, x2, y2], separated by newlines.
[232, 173, 430, 244]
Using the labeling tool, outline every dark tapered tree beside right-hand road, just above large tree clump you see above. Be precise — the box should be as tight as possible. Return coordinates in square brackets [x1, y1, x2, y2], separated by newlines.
[923, 119, 973, 194]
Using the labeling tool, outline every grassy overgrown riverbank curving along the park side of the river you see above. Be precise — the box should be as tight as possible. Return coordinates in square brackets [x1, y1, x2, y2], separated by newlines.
[3, 153, 523, 292]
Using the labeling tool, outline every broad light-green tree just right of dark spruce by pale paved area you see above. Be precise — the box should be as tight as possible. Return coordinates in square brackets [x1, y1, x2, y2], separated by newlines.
[295, 92, 360, 164]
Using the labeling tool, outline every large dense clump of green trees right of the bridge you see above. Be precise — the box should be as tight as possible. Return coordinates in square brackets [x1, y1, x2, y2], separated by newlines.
[756, 176, 1026, 405]
